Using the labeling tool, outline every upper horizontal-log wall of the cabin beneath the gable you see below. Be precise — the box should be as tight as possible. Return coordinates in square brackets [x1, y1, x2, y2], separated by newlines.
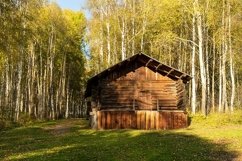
[92, 64, 185, 110]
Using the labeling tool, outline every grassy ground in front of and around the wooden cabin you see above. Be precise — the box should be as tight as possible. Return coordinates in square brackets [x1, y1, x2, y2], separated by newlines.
[0, 112, 242, 161]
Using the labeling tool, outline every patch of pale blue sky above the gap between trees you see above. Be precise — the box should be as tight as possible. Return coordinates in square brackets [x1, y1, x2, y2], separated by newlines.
[55, 0, 91, 19]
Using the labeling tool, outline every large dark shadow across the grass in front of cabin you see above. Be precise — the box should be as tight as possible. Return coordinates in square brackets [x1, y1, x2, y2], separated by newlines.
[0, 119, 237, 161]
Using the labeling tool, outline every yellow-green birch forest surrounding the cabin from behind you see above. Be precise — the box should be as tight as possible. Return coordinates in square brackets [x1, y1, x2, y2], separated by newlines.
[0, 0, 242, 121]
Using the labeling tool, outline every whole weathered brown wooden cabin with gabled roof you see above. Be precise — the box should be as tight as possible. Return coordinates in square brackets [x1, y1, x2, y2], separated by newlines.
[85, 53, 191, 129]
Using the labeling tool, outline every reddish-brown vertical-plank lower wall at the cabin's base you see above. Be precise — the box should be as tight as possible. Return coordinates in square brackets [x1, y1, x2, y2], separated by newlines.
[96, 110, 187, 130]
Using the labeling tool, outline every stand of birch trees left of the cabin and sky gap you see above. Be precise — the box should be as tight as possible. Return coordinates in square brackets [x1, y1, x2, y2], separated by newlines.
[0, 0, 86, 121]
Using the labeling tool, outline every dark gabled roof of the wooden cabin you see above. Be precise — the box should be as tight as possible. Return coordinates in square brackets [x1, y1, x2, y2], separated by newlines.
[85, 53, 192, 97]
